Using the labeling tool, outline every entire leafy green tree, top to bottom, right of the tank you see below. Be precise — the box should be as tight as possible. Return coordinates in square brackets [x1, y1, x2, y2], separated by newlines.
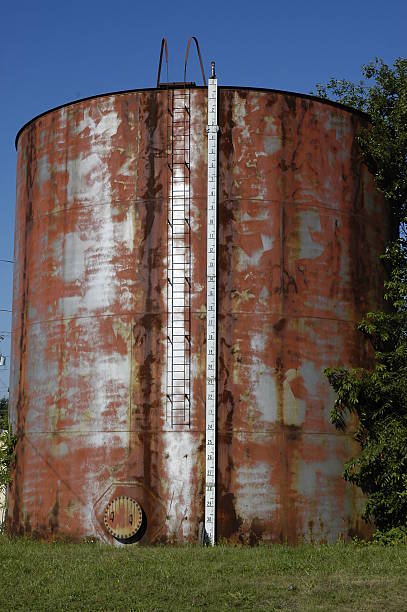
[317, 58, 407, 531]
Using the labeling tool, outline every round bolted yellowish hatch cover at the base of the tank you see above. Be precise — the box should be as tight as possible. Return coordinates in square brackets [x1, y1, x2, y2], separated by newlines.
[104, 495, 143, 540]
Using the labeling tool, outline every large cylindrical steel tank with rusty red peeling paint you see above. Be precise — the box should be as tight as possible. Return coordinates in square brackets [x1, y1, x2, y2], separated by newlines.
[8, 86, 390, 543]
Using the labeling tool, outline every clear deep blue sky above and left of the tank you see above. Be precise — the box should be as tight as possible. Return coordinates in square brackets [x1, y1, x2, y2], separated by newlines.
[0, 0, 407, 396]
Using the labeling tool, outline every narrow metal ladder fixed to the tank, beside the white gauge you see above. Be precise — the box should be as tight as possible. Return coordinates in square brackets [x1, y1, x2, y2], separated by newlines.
[166, 86, 191, 428]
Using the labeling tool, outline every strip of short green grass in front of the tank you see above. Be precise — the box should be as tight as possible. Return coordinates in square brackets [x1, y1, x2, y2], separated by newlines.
[0, 536, 407, 612]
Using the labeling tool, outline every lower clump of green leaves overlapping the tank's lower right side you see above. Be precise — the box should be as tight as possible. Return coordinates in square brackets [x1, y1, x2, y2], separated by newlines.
[325, 238, 407, 530]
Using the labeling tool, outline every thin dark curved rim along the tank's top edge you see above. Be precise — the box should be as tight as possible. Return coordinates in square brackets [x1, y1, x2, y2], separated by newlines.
[14, 83, 370, 149]
